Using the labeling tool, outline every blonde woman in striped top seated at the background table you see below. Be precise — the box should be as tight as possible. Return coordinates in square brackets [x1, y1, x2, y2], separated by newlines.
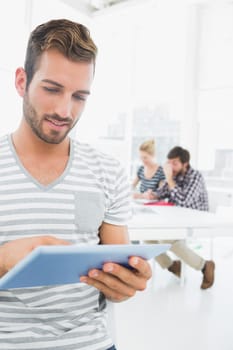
[132, 139, 165, 199]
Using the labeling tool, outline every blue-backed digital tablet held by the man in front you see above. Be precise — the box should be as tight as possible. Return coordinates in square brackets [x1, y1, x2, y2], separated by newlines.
[0, 244, 170, 289]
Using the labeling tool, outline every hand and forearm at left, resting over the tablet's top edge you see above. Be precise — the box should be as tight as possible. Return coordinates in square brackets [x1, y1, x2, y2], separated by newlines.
[0, 236, 70, 277]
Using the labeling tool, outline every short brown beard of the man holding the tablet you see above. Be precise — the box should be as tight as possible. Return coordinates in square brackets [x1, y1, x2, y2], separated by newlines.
[23, 94, 78, 144]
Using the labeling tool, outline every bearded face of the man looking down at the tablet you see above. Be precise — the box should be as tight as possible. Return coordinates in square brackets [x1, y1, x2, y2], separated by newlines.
[16, 50, 94, 144]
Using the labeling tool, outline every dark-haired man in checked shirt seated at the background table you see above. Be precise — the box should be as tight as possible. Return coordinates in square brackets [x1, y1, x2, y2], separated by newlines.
[148, 146, 215, 289]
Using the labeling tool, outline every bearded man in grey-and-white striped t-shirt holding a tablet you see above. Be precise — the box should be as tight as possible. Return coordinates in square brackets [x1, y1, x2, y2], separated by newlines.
[0, 20, 151, 350]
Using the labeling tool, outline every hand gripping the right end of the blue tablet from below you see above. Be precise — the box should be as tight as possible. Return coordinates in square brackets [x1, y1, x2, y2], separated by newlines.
[80, 257, 152, 302]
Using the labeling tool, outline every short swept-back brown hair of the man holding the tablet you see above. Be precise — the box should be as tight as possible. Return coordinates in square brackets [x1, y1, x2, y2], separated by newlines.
[24, 19, 97, 87]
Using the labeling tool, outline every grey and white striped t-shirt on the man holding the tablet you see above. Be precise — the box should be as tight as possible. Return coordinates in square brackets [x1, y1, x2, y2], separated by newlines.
[0, 136, 130, 350]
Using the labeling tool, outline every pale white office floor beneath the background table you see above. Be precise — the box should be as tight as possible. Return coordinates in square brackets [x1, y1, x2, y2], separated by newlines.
[114, 238, 233, 350]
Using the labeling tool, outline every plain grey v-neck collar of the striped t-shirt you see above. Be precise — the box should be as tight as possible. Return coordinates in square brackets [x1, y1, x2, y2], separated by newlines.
[8, 135, 74, 191]
